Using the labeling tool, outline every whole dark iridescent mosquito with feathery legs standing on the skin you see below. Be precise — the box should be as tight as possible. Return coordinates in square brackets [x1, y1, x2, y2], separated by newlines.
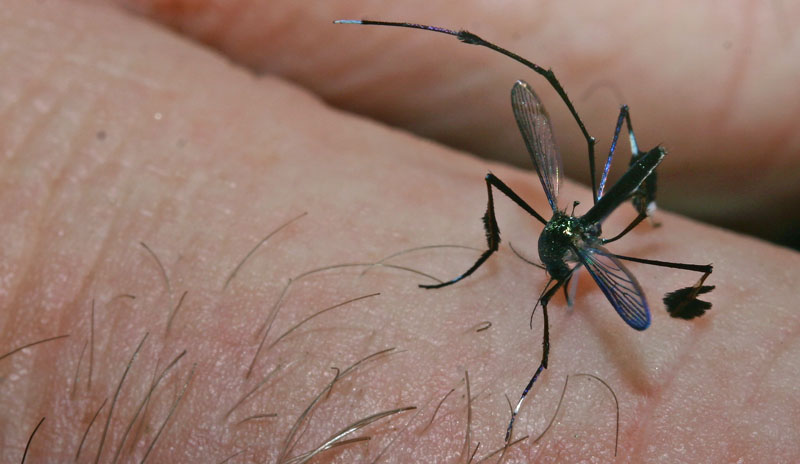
[335, 20, 714, 442]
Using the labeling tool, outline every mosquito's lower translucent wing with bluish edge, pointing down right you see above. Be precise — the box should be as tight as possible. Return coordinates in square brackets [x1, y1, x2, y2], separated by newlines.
[577, 245, 650, 330]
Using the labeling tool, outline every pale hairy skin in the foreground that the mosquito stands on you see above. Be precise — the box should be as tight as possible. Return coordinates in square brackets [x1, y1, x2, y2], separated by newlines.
[0, 1, 800, 462]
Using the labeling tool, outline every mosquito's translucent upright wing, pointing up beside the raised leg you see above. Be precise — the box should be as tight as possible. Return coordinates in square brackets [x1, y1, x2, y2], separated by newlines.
[511, 81, 564, 211]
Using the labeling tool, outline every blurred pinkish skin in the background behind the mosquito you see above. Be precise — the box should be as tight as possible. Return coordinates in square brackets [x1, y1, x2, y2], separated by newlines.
[117, 0, 800, 248]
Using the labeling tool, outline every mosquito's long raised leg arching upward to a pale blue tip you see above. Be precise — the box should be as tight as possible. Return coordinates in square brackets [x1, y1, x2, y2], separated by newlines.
[333, 19, 597, 202]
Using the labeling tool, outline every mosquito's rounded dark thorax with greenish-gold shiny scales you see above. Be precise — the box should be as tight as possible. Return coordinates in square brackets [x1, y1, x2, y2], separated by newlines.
[539, 211, 586, 280]
